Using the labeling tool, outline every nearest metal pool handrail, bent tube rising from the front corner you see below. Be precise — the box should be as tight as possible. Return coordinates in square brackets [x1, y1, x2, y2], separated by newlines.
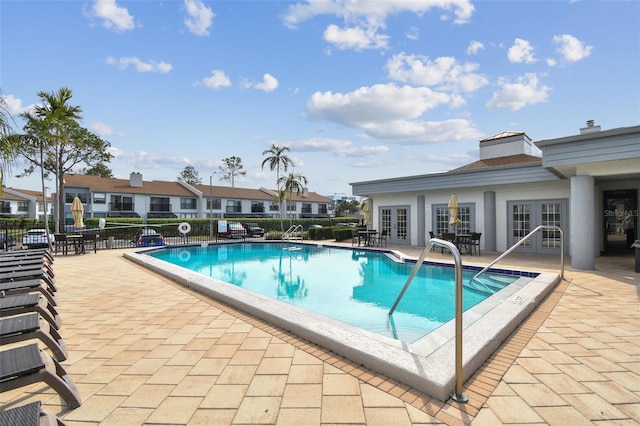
[389, 238, 469, 403]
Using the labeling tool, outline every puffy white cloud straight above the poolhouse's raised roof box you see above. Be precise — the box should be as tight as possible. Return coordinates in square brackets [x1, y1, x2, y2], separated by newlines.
[487, 73, 551, 111]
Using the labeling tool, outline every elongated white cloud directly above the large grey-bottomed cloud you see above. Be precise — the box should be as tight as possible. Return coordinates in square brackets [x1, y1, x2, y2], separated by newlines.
[386, 53, 489, 92]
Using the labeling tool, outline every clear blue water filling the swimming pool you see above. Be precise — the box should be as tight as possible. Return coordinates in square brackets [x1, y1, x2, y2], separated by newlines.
[147, 243, 517, 342]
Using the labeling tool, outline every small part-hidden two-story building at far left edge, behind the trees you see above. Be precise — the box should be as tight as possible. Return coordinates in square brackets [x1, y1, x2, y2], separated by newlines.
[0, 188, 53, 220]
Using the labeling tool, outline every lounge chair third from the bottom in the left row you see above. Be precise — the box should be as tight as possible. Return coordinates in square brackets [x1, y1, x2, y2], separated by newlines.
[0, 312, 67, 362]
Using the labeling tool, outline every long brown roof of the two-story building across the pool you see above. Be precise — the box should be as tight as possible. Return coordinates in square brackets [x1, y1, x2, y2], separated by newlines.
[64, 174, 333, 203]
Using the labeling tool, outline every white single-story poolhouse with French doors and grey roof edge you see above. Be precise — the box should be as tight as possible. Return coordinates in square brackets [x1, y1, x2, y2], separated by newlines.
[350, 121, 640, 269]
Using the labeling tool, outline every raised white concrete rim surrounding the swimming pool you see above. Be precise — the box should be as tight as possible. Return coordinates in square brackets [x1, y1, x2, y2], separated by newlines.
[124, 242, 560, 401]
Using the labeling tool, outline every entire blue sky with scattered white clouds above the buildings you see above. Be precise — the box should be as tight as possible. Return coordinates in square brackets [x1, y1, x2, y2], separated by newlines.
[0, 0, 640, 195]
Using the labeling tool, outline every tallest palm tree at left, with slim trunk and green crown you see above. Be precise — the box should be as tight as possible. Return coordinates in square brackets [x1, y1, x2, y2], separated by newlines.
[33, 87, 82, 232]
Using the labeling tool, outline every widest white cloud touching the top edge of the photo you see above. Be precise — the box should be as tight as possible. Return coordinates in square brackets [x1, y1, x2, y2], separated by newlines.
[283, 0, 474, 50]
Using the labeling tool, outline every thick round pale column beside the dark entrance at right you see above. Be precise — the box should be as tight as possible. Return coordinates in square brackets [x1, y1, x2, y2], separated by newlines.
[570, 176, 596, 270]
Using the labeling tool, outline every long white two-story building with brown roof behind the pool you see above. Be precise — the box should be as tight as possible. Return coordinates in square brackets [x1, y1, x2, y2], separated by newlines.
[64, 173, 334, 221]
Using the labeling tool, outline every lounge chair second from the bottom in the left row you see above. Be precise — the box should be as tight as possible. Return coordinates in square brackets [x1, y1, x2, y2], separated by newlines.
[0, 343, 81, 408]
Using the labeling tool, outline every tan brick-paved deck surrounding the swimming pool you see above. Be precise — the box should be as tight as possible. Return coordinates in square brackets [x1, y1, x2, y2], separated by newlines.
[0, 247, 640, 425]
